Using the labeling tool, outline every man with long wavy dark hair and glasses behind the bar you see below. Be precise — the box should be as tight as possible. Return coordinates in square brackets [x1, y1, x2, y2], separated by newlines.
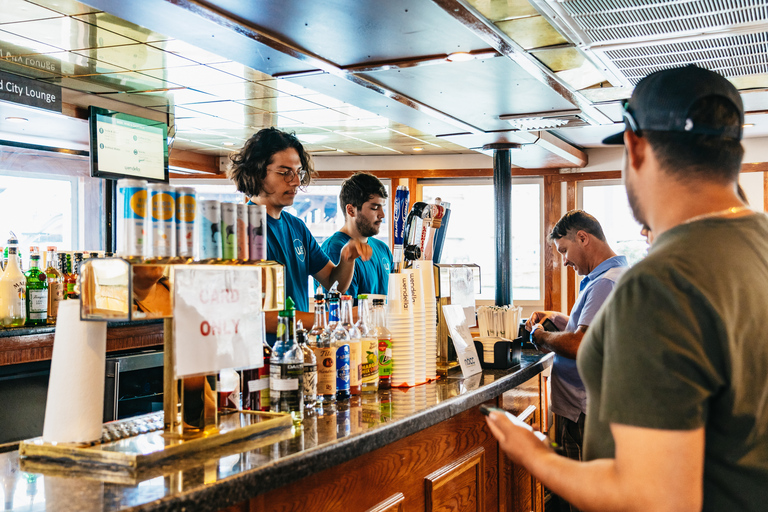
[227, 128, 371, 333]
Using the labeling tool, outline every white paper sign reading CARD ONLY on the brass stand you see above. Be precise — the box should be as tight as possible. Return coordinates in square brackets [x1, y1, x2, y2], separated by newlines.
[173, 265, 264, 379]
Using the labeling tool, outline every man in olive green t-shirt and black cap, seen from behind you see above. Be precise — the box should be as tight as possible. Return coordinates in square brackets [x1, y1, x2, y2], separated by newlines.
[488, 66, 768, 512]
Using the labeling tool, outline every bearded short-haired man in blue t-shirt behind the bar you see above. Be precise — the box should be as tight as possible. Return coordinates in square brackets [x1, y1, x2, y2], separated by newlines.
[322, 172, 392, 298]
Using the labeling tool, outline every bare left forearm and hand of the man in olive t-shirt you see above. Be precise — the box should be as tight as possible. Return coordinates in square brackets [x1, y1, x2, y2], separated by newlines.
[488, 413, 704, 512]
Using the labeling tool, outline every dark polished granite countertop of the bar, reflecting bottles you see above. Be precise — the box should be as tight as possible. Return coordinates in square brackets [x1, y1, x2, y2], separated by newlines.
[0, 351, 552, 512]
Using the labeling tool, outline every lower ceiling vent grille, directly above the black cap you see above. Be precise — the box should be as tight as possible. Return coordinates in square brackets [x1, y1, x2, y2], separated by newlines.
[604, 32, 768, 85]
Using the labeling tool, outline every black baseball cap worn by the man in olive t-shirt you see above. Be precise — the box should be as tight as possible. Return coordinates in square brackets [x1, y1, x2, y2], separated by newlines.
[603, 65, 744, 144]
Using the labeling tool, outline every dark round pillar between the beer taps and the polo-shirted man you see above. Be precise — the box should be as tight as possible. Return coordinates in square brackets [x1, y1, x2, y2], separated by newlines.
[483, 143, 520, 306]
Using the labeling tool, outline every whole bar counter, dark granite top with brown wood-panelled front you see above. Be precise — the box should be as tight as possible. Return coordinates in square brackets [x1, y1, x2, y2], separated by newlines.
[0, 351, 552, 512]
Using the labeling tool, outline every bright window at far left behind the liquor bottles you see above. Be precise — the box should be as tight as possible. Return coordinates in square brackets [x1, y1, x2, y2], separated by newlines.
[0, 146, 104, 268]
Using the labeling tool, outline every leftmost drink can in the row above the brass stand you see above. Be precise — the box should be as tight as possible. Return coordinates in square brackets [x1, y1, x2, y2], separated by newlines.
[117, 179, 148, 258]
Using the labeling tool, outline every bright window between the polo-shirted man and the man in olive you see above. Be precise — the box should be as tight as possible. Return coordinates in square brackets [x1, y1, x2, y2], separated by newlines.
[579, 180, 648, 265]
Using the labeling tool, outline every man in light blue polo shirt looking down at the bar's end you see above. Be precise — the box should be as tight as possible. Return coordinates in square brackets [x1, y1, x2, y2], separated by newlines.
[525, 210, 627, 511]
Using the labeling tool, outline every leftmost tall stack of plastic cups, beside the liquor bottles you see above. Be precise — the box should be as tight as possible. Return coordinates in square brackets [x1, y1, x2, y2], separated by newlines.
[387, 272, 416, 387]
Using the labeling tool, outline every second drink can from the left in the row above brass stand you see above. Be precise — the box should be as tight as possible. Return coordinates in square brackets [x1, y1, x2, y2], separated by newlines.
[144, 183, 176, 258]
